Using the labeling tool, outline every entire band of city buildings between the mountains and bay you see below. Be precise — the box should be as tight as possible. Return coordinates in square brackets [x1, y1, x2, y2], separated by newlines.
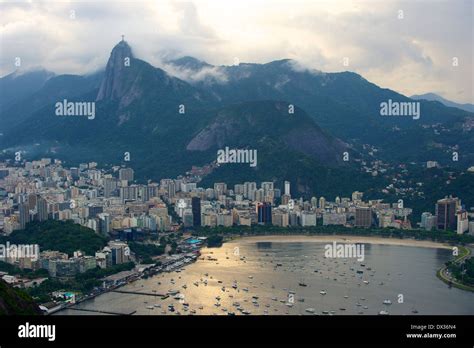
[0, 158, 474, 275]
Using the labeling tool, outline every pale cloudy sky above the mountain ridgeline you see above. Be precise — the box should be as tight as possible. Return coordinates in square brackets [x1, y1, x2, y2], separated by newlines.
[0, 0, 474, 103]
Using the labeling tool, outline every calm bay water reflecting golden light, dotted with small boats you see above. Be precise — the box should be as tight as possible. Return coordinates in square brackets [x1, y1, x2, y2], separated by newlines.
[58, 239, 474, 315]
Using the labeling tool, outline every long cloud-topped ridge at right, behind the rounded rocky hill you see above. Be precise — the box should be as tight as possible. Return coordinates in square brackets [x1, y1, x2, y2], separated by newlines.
[180, 59, 474, 166]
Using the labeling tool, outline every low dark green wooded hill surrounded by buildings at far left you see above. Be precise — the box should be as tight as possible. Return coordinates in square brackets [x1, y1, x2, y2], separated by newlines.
[0, 220, 107, 256]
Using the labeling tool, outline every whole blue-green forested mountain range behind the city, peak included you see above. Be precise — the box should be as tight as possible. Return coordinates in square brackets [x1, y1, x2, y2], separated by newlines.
[0, 40, 474, 197]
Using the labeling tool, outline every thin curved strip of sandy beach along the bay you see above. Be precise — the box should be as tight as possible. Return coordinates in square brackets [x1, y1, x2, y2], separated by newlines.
[230, 235, 453, 249]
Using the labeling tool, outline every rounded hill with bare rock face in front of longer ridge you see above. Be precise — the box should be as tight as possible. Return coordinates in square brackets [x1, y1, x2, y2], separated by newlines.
[186, 101, 348, 165]
